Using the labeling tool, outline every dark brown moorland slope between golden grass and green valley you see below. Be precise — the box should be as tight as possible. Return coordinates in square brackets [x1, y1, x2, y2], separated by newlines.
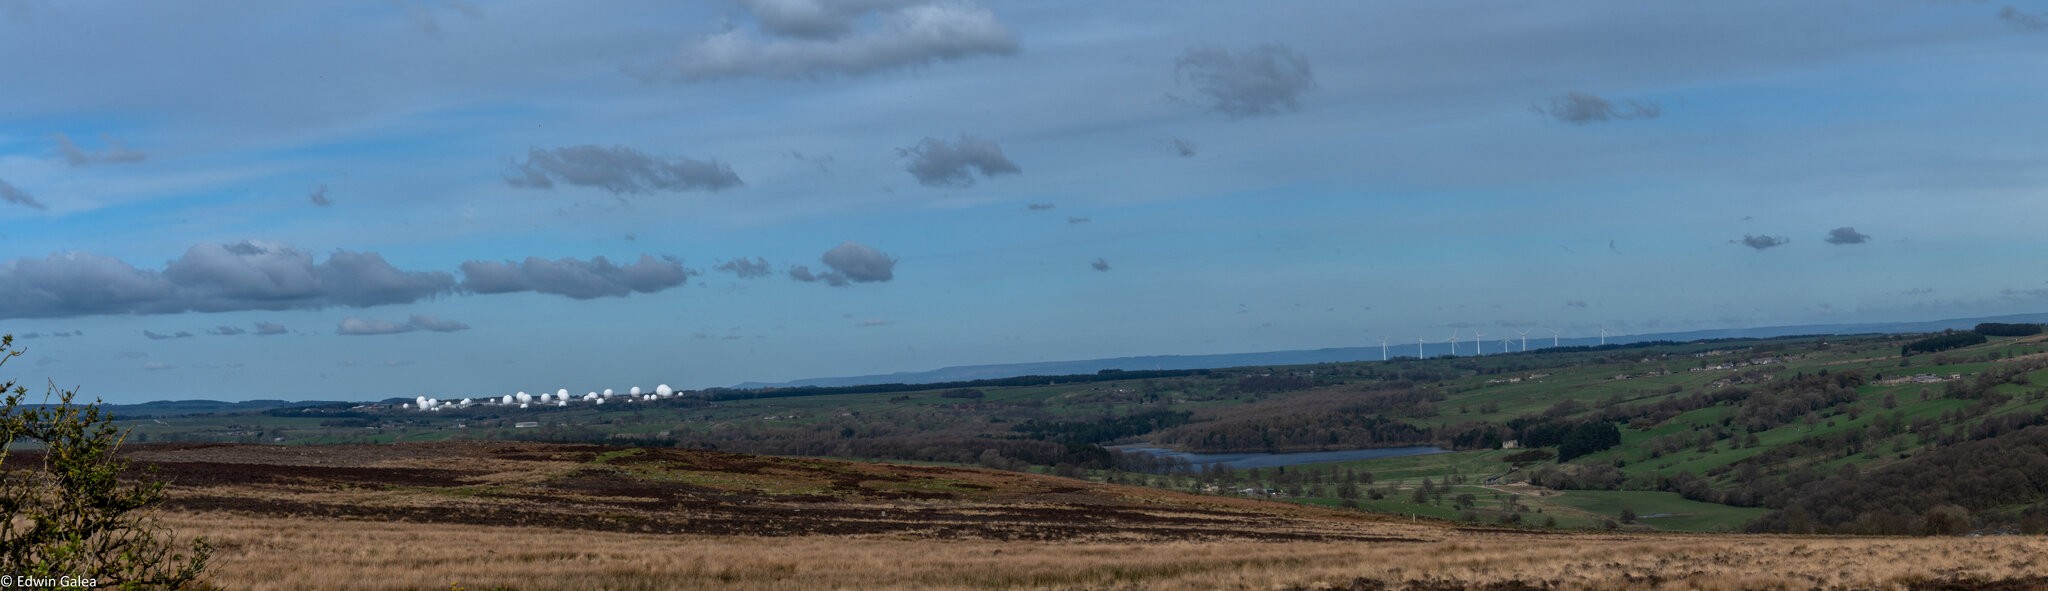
[131, 442, 1434, 542]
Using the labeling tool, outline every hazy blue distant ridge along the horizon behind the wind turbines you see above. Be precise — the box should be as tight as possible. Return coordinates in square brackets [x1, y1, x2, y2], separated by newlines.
[733, 313, 2048, 391]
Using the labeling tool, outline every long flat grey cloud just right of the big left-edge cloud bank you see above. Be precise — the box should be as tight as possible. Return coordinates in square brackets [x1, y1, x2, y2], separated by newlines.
[463, 254, 700, 301]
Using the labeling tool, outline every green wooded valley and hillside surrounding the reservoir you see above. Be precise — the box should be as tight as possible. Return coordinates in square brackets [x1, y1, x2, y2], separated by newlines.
[116, 327, 2048, 534]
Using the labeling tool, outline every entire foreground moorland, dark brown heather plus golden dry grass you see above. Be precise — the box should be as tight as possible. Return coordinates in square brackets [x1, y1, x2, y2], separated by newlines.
[75, 444, 2048, 589]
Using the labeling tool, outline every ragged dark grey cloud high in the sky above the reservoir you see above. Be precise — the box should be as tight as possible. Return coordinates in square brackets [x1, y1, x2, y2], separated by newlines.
[1174, 43, 1315, 117]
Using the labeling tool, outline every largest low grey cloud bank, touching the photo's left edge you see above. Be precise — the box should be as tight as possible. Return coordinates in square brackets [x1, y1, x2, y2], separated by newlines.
[0, 241, 455, 317]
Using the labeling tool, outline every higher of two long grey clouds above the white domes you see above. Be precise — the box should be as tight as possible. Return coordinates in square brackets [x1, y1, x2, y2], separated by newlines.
[506, 145, 743, 194]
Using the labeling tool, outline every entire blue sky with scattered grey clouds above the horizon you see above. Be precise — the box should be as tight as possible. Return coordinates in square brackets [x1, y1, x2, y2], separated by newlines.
[0, 0, 2048, 403]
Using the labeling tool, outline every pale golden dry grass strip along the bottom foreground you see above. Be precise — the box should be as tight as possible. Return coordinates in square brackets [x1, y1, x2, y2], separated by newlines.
[166, 513, 2048, 589]
